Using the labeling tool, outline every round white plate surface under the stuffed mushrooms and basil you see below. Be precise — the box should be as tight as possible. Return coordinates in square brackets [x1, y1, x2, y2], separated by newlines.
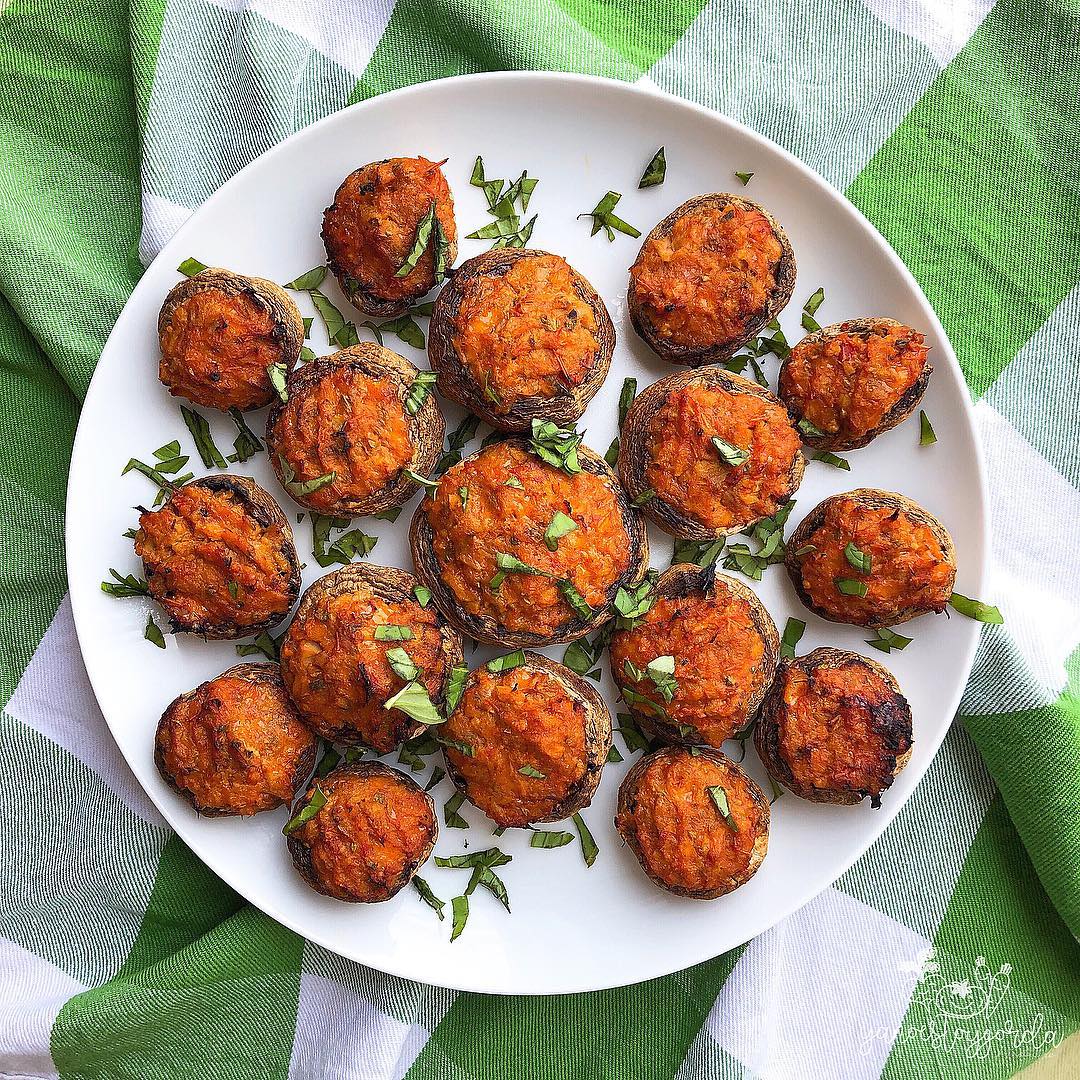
[67, 73, 986, 994]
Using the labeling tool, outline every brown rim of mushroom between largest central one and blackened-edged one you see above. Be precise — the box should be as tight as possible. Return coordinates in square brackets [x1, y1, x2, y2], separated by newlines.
[611, 563, 780, 746]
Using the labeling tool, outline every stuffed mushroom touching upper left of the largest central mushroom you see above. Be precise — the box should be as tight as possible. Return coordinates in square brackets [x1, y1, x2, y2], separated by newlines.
[267, 341, 446, 517]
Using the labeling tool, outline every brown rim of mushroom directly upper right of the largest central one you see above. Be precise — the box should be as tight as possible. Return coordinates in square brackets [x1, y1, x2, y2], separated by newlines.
[618, 367, 807, 540]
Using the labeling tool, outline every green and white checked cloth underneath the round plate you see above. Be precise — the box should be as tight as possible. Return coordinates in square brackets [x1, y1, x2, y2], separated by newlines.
[0, 0, 1080, 1080]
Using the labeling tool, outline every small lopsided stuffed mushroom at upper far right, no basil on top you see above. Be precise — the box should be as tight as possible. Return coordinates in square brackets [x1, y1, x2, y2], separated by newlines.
[778, 319, 933, 450]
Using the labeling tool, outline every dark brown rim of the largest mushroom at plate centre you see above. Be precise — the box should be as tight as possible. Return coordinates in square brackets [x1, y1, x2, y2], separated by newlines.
[409, 438, 649, 649]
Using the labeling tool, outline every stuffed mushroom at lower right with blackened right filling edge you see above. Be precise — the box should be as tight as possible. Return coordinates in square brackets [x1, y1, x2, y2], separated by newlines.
[754, 649, 912, 808]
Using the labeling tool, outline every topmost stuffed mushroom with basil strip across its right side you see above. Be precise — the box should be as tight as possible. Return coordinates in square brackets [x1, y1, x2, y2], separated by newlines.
[323, 158, 458, 319]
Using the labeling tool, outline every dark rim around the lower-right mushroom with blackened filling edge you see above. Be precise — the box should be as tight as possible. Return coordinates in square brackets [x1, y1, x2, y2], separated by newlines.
[754, 648, 912, 810]
